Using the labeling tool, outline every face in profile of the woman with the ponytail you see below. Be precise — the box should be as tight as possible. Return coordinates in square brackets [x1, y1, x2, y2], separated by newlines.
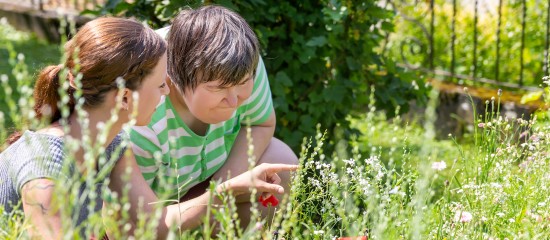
[133, 53, 170, 126]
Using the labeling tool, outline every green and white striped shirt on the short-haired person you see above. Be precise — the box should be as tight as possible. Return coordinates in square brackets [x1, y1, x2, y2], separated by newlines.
[130, 27, 273, 199]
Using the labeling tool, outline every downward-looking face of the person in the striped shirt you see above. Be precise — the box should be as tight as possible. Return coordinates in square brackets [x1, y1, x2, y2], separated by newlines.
[183, 74, 254, 124]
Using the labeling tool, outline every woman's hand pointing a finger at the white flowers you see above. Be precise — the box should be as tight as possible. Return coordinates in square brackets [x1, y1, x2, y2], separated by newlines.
[217, 163, 298, 196]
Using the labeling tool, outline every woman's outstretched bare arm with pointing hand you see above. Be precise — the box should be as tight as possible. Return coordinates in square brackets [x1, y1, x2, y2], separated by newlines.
[106, 147, 298, 239]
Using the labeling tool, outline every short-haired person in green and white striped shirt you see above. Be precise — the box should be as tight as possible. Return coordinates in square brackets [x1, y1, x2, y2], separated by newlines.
[131, 6, 297, 223]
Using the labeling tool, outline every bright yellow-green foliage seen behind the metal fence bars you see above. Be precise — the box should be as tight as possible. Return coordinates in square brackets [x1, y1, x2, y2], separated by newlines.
[387, 0, 548, 86]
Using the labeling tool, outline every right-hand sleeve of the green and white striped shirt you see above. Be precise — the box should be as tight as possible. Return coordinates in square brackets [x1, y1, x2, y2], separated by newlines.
[239, 57, 273, 125]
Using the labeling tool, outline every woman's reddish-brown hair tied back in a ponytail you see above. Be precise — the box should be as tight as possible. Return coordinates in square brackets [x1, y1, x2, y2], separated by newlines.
[7, 17, 166, 144]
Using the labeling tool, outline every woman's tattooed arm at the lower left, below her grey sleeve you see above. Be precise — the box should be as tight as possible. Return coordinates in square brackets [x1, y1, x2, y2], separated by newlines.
[21, 178, 62, 239]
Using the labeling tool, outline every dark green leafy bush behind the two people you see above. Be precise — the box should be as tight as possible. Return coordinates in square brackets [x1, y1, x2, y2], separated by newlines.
[88, 0, 432, 150]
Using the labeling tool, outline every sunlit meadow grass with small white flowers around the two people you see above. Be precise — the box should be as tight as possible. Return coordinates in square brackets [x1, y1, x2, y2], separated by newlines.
[0, 19, 550, 239]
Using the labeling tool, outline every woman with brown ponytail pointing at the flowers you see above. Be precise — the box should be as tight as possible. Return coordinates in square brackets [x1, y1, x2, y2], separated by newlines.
[0, 18, 296, 239]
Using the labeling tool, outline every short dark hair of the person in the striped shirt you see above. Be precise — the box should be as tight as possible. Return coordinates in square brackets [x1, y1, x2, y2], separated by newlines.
[168, 5, 259, 91]
